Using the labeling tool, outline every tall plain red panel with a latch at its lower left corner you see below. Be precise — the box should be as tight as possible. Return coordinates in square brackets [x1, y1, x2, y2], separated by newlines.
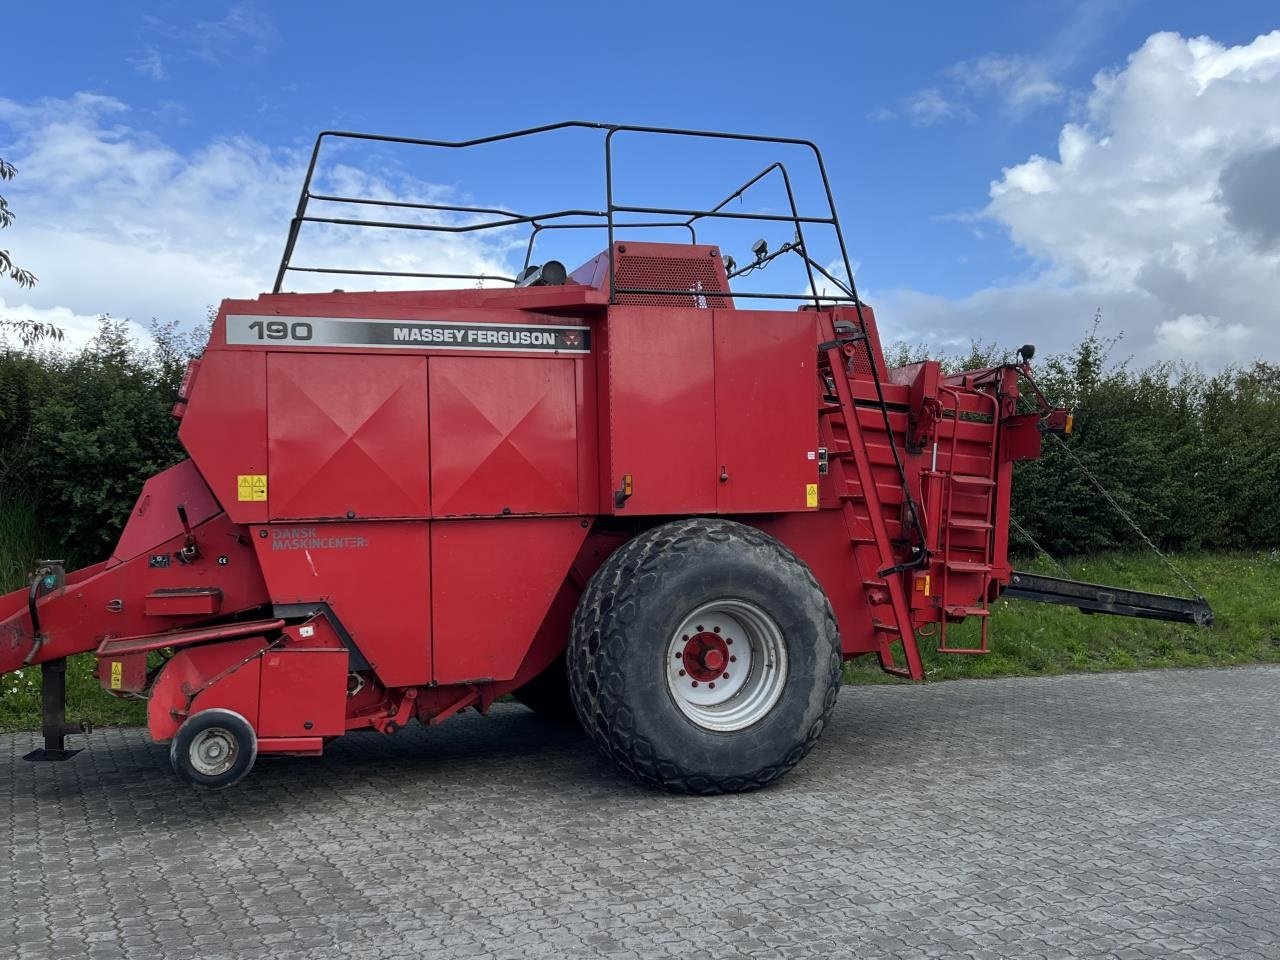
[600, 306, 719, 516]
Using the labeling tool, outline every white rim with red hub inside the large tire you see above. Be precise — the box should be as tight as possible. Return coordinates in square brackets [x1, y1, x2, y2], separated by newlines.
[666, 599, 787, 731]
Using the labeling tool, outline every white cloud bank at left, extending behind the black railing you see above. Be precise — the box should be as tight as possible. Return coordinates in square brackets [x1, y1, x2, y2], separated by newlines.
[0, 93, 511, 337]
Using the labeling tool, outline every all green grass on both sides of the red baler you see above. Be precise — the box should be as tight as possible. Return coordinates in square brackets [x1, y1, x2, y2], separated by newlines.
[0, 503, 1280, 731]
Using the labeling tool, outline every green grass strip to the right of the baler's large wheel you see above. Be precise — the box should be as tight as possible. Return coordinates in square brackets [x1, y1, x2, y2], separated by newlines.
[845, 550, 1280, 684]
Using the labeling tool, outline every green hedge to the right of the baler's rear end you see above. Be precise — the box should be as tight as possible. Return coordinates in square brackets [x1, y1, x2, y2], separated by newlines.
[890, 323, 1280, 556]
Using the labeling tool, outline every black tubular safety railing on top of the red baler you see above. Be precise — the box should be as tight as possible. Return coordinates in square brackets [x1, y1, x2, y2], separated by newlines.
[273, 120, 856, 306]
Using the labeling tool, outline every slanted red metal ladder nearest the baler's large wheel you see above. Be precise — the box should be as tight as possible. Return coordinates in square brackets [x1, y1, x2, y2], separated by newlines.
[818, 320, 924, 680]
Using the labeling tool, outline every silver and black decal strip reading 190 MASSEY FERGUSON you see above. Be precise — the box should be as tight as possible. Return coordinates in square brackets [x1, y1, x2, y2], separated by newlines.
[227, 315, 591, 353]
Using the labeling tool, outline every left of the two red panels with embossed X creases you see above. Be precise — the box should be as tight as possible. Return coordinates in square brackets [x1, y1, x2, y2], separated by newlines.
[266, 353, 429, 520]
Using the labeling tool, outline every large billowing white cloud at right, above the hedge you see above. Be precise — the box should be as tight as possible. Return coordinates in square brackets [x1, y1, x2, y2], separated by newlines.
[886, 31, 1280, 365]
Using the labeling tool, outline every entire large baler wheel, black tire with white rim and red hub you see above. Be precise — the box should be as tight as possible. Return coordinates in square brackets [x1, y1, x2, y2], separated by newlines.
[568, 517, 841, 794]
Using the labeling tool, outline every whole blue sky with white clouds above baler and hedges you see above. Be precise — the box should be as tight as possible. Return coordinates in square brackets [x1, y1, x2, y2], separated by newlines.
[0, 0, 1280, 366]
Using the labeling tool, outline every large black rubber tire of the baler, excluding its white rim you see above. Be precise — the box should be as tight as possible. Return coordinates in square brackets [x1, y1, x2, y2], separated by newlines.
[568, 517, 841, 794]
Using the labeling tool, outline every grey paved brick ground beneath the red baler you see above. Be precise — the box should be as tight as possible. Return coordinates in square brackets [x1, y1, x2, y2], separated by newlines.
[0, 667, 1280, 960]
